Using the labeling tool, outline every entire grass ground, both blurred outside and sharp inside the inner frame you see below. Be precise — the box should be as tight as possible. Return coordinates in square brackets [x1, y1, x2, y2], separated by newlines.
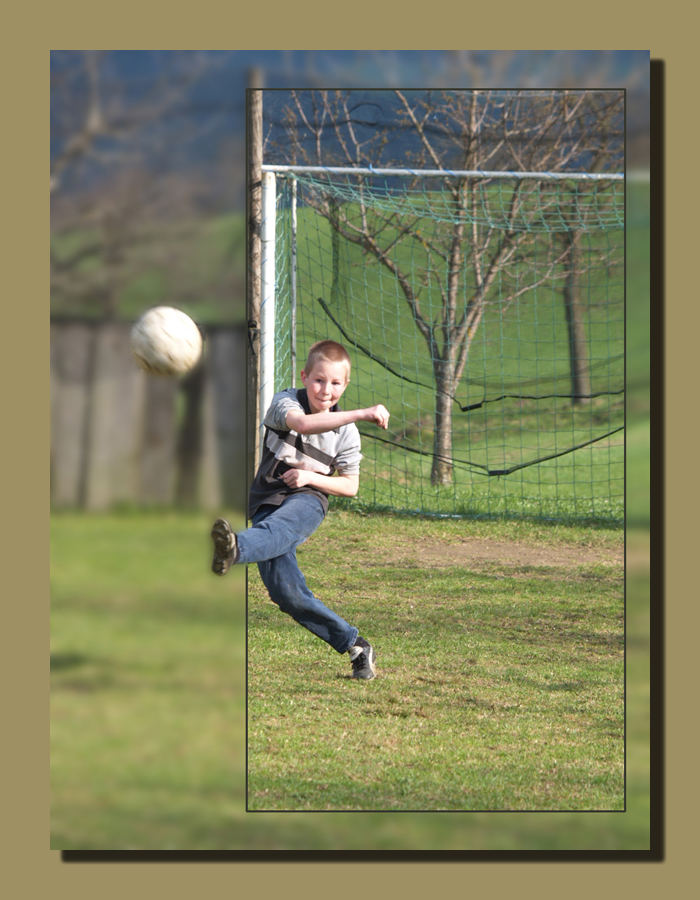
[51, 510, 648, 850]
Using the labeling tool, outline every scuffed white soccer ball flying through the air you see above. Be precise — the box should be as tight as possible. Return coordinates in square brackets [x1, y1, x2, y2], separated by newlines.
[131, 306, 202, 375]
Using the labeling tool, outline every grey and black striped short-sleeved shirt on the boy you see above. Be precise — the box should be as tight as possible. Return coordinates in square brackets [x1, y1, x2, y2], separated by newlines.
[248, 388, 362, 517]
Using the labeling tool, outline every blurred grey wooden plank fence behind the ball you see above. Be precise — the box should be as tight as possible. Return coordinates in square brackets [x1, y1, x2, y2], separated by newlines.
[51, 320, 247, 510]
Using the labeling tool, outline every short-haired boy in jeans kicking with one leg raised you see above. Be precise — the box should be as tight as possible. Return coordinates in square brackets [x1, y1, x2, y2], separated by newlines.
[211, 341, 389, 679]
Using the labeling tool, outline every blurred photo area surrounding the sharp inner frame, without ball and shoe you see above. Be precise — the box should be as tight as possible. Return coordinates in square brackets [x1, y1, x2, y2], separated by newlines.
[50, 50, 650, 850]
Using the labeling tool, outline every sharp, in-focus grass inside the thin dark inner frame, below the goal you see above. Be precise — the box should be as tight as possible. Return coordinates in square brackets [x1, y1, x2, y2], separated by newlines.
[249, 513, 624, 810]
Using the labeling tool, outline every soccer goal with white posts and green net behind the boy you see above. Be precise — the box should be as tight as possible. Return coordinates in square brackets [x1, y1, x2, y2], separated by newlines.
[260, 166, 625, 523]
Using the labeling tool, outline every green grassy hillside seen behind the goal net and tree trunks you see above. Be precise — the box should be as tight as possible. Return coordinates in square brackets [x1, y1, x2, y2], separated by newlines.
[270, 178, 649, 523]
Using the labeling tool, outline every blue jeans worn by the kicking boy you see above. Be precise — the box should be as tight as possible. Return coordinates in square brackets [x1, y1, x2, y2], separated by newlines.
[236, 493, 358, 653]
